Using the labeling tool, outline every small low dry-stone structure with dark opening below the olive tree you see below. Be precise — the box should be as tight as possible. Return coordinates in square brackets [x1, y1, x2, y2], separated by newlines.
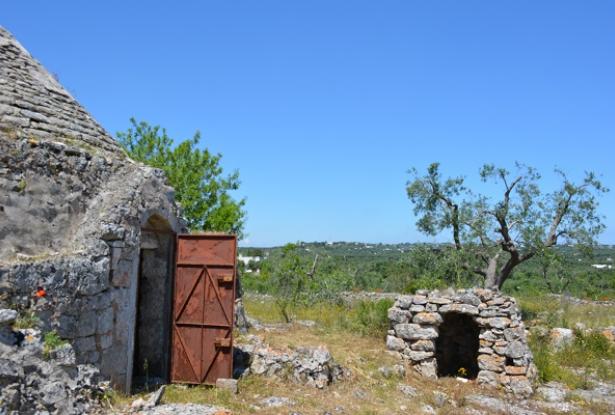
[386, 289, 536, 396]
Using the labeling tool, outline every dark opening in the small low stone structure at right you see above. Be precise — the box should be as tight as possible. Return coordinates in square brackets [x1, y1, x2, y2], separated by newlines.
[436, 313, 480, 379]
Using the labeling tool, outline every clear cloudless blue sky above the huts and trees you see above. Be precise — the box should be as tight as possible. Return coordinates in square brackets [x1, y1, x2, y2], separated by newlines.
[0, 0, 615, 246]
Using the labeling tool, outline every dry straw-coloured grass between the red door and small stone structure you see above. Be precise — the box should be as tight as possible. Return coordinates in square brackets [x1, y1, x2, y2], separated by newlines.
[156, 325, 508, 415]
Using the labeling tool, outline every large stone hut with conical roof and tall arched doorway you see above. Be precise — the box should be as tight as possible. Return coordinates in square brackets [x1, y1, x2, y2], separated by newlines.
[0, 27, 185, 391]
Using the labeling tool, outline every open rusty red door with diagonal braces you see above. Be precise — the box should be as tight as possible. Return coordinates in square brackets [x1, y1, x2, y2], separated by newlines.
[171, 234, 237, 385]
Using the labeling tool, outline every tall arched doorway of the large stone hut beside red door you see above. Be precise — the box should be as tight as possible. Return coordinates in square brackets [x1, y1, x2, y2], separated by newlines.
[132, 215, 175, 391]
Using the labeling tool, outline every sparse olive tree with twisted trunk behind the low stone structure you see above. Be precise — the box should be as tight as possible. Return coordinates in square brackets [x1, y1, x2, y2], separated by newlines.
[406, 163, 608, 289]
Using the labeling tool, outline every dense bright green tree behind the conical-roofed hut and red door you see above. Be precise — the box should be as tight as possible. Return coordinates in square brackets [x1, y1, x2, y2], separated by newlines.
[117, 118, 245, 237]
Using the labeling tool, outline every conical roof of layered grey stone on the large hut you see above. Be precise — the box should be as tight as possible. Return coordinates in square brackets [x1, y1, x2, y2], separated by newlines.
[0, 27, 120, 152]
